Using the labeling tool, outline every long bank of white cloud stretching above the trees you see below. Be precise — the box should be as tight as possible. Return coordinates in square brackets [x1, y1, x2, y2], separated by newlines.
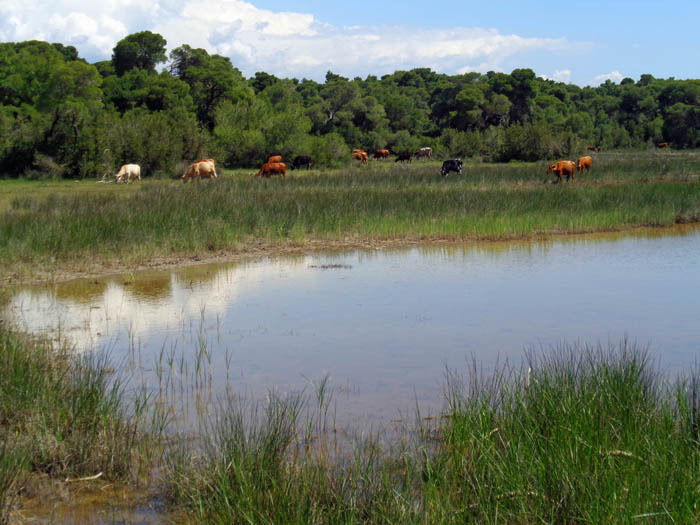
[0, 0, 571, 79]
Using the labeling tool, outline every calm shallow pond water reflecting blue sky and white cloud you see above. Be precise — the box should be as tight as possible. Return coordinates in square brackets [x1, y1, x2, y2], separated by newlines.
[4, 230, 700, 424]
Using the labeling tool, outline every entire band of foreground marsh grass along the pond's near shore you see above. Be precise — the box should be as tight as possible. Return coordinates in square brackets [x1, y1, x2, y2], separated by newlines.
[5, 329, 700, 523]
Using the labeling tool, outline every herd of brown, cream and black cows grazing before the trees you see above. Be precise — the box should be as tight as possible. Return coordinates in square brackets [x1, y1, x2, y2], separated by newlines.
[109, 142, 669, 184]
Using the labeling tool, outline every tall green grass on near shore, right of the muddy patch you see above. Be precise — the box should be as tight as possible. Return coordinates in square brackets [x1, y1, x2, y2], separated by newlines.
[165, 343, 700, 523]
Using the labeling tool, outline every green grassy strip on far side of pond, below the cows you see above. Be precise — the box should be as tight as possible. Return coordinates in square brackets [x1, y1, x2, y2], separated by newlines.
[0, 153, 700, 280]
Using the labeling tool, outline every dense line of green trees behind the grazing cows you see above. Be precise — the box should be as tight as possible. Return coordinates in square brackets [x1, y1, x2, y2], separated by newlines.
[0, 31, 700, 177]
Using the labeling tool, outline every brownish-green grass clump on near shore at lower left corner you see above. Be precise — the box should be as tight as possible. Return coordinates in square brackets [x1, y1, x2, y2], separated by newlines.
[0, 324, 154, 523]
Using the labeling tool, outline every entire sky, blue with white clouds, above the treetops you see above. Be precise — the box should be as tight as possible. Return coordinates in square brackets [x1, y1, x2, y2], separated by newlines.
[0, 0, 700, 86]
